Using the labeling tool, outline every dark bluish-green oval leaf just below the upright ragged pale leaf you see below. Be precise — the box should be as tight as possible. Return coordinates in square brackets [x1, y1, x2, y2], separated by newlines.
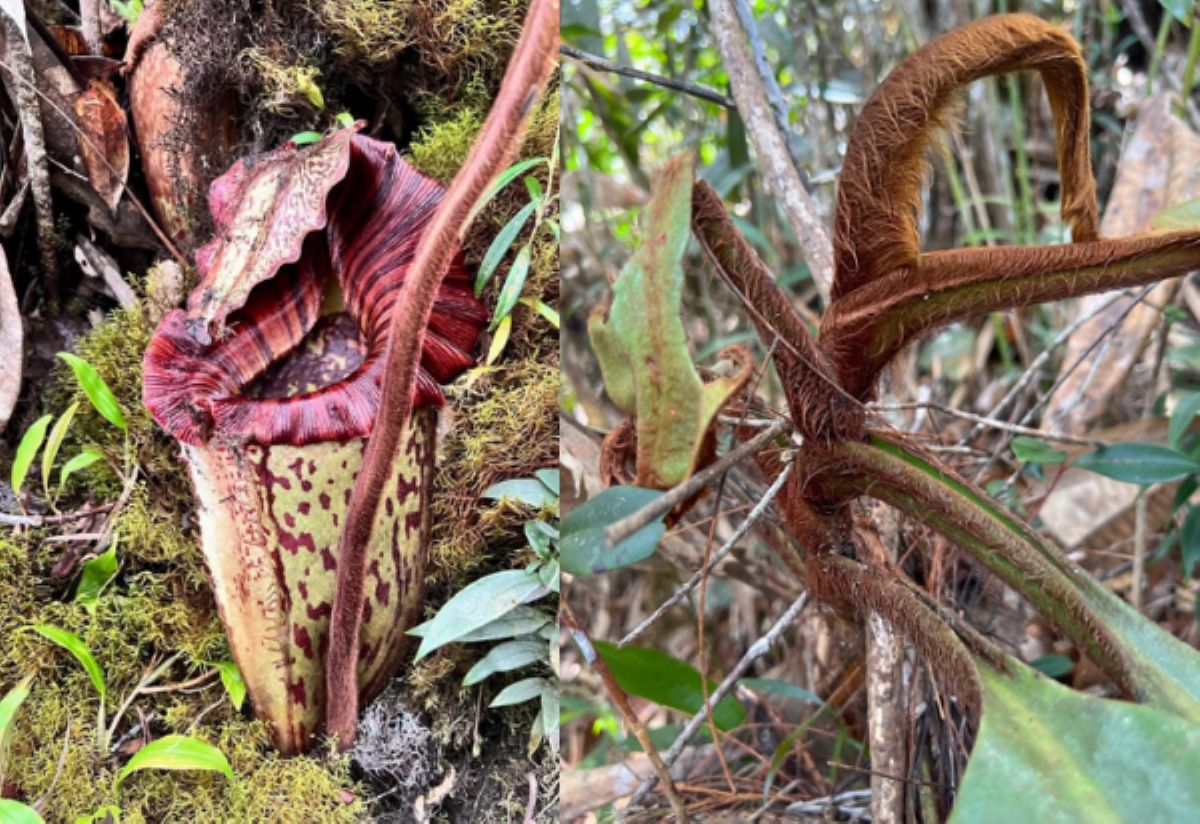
[560, 487, 667, 575]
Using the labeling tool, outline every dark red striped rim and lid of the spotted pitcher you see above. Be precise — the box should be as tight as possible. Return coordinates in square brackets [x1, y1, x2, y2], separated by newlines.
[143, 126, 487, 446]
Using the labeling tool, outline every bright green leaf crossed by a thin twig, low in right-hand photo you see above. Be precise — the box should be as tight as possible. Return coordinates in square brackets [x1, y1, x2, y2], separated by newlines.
[595, 640, 745, 730]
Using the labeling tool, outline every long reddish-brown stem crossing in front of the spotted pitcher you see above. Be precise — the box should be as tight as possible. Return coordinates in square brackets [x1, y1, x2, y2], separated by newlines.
[325, 0, 559, 750]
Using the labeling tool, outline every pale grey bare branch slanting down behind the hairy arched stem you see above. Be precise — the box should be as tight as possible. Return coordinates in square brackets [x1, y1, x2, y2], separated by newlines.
[709, 0, 833, 305]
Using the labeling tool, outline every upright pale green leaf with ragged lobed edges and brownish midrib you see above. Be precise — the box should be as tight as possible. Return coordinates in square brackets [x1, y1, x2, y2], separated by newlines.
[588, 155, 752, 489]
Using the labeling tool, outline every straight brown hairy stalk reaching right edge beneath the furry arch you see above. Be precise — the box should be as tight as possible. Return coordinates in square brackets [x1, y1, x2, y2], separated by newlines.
[820, 230, 1200, 398]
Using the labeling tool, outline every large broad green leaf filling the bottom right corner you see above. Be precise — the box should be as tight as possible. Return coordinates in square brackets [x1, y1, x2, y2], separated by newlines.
[950, 663, 1200, 824]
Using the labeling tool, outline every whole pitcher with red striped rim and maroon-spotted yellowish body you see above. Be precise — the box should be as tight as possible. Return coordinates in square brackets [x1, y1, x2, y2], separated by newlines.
[144, 124, 487, 753]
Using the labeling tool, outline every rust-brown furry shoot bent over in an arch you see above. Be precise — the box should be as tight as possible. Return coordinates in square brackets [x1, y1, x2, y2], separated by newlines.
[833, 14, 1097, 301]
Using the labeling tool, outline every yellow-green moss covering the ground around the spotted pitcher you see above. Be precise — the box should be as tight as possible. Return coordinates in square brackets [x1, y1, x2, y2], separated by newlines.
[0, 0, 558, 824]
